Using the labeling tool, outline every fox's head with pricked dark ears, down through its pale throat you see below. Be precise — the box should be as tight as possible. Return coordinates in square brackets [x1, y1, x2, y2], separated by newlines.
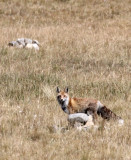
[56, 87, 69, 114]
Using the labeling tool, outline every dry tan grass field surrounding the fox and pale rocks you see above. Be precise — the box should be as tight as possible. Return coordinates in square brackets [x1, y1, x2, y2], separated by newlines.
[0, 0, 131, 160]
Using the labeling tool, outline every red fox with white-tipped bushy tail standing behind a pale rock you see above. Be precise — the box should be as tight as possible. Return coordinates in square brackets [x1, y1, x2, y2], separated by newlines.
[56, 87, 124, 125]
